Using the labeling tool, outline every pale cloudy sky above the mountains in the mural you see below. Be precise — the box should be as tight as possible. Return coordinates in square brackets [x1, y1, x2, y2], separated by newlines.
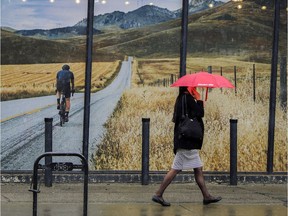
[1, 0, 227, 30]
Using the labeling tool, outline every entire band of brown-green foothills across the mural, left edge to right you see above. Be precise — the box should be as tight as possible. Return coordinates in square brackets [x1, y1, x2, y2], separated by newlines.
[1, 0, 287, 64]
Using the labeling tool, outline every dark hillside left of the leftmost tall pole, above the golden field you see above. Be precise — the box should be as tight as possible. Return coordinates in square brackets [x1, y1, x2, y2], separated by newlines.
[1, 30, 85, 64]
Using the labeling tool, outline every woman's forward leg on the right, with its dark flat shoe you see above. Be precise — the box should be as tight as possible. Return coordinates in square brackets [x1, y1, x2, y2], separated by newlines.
[194, 167, 222, 204]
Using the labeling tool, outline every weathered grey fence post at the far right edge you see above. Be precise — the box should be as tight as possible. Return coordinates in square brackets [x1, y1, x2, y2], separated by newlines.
[280, 57, 287, 112]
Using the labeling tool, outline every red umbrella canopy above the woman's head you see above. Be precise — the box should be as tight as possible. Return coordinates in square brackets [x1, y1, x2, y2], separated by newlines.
[171, 71, 234, 88]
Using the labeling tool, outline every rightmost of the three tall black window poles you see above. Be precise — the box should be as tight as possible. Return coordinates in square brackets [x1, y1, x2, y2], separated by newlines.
[267, 0, 280, 174]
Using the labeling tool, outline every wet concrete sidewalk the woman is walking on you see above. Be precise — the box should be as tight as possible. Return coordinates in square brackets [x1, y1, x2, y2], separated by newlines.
[1, 183, 287, 216]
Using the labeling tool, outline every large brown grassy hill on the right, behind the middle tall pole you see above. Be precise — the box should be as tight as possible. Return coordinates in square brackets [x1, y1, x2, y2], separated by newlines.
[98, 1, 287, 62]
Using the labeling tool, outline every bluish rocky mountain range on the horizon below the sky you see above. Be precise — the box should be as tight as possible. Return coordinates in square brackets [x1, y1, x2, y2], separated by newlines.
[15, 0, 223, 39]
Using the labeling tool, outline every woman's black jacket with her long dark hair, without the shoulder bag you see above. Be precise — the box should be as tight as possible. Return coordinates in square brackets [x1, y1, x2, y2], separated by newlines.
[173, 92, 204, 154]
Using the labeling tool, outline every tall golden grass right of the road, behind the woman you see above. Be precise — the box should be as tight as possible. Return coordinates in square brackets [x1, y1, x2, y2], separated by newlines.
[93, 58, 287, 172]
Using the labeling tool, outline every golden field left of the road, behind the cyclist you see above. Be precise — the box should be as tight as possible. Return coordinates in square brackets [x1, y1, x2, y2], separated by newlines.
[1, 61, 120, 101]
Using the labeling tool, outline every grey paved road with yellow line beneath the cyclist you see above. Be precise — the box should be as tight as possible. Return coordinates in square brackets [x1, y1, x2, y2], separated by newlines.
[1, 57, 132, 170]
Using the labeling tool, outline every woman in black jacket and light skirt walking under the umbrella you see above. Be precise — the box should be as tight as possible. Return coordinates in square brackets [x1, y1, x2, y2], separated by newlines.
[152, 87, 222, 206]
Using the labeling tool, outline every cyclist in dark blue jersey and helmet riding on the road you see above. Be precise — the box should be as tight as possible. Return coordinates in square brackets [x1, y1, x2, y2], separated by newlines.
[56, 64, 75, 122]
